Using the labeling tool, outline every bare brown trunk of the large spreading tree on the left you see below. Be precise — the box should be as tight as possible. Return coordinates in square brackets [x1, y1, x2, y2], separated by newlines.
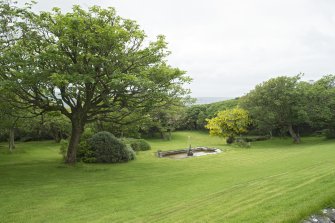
[66, 118, 85, 164]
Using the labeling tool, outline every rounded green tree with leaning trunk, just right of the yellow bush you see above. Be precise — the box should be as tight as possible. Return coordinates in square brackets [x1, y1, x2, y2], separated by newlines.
[241, 75, 306, 143]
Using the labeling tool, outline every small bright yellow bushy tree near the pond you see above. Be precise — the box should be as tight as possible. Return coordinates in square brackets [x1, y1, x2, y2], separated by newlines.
[205, 108, 250, 143]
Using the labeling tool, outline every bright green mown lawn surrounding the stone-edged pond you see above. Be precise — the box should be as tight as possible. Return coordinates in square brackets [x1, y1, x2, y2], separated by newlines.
[0, 132, 335, 222]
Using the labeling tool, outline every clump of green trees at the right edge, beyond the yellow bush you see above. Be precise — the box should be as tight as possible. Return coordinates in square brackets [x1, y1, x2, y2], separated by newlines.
[240, 75, 335, 143]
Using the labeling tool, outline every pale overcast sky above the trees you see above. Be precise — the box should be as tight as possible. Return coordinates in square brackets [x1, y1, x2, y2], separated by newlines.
[19, 0, 335, 97]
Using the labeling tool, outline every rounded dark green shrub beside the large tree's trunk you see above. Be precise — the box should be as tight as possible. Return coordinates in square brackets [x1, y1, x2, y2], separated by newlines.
[90, 132, 135, 163]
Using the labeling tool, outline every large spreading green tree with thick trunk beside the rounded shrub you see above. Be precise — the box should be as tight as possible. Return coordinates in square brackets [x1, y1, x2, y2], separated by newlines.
[0, 4, 190, 163]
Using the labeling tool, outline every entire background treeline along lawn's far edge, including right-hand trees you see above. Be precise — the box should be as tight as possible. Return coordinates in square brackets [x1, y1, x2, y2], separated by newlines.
[0, 75, 335, 146]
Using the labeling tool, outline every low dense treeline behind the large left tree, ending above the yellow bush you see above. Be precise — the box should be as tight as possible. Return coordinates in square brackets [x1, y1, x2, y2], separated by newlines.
[0, 98, 239, 142]
